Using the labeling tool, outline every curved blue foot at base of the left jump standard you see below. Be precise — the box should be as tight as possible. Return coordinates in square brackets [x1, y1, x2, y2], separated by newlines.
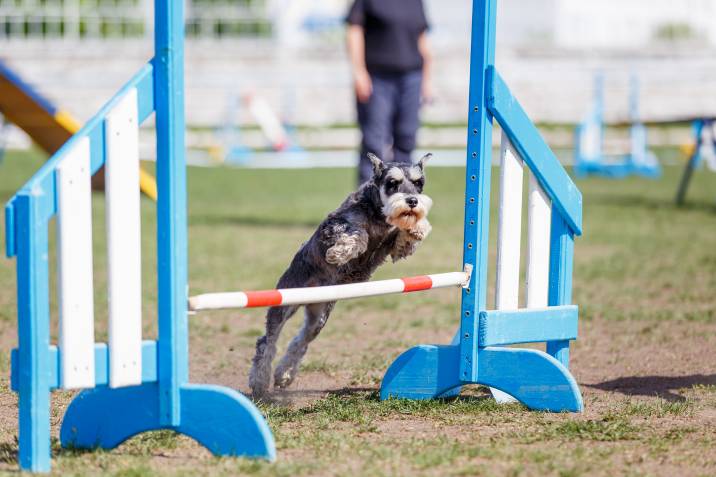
[60, 383, 276, 461]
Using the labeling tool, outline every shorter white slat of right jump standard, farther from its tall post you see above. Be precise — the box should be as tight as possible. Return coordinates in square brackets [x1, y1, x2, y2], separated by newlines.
[527, 172, 552, 308]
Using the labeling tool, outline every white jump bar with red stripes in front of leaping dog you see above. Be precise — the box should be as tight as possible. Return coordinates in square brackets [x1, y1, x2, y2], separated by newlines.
[189, 267, 470, 311]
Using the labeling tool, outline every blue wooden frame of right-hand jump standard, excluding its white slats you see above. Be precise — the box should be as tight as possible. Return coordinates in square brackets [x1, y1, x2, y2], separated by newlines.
[381, 0, 583, 412]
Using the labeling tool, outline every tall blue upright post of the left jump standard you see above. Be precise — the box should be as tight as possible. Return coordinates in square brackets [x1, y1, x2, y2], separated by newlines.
[154, 0, 188, 426]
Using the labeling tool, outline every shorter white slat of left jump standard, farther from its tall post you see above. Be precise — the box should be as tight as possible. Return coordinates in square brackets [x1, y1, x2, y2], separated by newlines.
[56, 137, 95, 389]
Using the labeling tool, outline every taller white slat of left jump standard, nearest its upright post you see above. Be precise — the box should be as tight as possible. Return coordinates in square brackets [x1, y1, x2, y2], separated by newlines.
[105, 89, 142, 388]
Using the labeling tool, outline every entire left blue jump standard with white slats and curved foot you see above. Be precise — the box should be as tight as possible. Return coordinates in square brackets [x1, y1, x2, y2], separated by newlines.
[5, 0, 276, 472]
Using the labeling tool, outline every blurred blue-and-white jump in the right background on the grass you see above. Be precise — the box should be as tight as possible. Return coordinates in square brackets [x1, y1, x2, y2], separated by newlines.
[574, 75, 661, 179]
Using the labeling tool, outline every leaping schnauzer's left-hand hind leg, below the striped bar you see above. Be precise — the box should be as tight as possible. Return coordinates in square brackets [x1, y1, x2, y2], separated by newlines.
[249, 306, 298, 398]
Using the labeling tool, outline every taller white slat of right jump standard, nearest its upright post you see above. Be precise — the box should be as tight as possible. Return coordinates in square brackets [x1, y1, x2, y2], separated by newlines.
[495, 132, 523, 310]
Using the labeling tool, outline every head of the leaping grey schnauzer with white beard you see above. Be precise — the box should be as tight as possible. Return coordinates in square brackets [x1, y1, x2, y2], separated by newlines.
[368, 154, 433, 230]
